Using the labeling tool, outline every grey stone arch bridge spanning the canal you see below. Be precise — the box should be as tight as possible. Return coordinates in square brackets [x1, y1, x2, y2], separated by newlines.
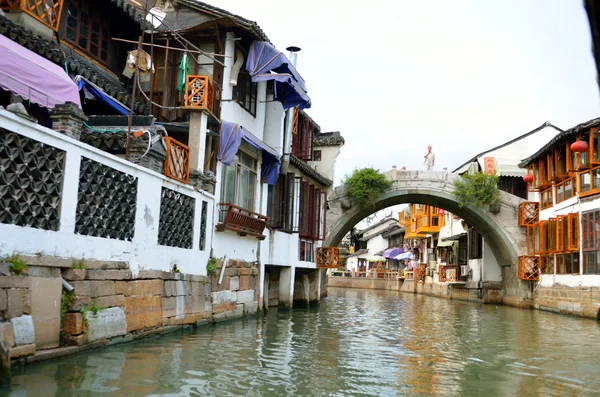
[323, 171, 528, 297]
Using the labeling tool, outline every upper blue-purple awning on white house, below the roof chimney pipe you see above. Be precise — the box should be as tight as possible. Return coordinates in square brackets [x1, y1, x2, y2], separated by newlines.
[246, 41, 311, 109]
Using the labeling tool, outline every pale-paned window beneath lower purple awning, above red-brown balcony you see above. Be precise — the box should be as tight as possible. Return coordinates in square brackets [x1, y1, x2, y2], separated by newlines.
[220, 151, 256, 222]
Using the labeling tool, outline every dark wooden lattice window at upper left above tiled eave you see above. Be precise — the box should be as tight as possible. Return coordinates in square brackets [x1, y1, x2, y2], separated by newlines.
[64, 0, 111, 65]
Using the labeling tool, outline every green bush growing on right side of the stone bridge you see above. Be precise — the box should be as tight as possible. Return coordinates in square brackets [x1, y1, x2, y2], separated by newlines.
[454, 172, 500, 208]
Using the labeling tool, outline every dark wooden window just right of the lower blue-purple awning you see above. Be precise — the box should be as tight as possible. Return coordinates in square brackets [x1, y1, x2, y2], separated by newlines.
[267, 172, 301, 233]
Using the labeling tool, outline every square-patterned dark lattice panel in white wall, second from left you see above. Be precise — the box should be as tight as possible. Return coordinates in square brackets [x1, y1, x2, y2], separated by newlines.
[75, 157, 137, 241]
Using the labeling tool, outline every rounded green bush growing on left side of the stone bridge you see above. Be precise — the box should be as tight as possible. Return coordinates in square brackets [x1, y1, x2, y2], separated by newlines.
[344, 167, 392, 205]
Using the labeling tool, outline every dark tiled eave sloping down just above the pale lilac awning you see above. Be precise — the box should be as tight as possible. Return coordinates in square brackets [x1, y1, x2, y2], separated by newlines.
[0, 13, 148, 114]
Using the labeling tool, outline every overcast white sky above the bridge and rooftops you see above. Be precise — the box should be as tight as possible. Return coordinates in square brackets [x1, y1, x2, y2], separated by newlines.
[207, 0, 600, 185]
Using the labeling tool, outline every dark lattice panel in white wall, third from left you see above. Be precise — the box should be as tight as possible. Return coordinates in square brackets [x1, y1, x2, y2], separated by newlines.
[158, 187, 195, 249]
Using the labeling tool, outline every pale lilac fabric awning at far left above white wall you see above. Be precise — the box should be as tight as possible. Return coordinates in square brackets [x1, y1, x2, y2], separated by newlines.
[0, 35, 81, 109]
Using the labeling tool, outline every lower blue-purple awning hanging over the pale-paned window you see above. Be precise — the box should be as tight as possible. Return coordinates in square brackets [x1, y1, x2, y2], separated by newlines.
[217, 120, 281, 185]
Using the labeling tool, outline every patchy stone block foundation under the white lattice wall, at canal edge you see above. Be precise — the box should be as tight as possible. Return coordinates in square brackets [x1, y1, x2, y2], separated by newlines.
[0, 256, 259, 362]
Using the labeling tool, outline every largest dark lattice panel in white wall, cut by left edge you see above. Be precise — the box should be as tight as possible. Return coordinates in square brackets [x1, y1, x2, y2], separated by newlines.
[0, 128, 65, 231]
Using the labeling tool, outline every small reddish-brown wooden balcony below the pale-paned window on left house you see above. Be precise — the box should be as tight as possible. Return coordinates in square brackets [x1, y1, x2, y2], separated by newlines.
[216, 203, 269, 240]
